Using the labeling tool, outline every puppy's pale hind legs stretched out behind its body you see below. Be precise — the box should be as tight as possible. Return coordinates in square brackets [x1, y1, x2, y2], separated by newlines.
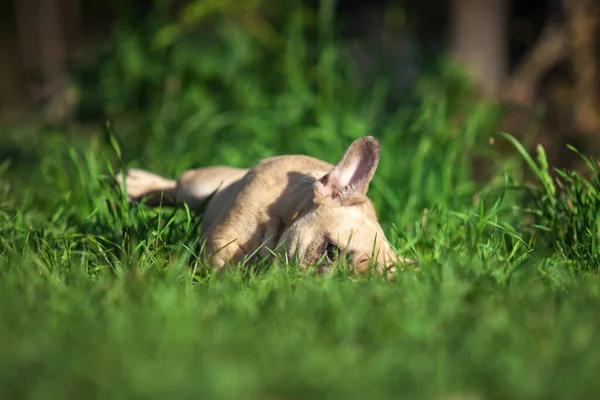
[117, 166, 246, 209]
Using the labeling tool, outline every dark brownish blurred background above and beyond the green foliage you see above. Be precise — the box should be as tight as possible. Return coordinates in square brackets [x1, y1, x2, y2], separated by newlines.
[0, 0, 600, 170]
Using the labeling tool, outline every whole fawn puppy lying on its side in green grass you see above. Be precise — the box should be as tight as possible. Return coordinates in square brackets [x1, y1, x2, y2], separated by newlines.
[117, 136, 412, 273]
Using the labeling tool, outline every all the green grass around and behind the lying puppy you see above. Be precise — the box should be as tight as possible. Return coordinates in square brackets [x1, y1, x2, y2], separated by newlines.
[0, 3, 600, 399]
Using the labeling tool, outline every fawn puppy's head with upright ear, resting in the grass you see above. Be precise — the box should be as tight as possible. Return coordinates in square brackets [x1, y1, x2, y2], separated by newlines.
[281, 137, 402, 273]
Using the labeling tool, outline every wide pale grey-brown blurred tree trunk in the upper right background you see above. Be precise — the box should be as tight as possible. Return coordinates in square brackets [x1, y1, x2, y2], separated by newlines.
[450, 0, 508, 96]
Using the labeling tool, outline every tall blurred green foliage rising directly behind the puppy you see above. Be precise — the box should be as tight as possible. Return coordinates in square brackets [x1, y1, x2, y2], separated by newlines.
[61, 1, 497, 216]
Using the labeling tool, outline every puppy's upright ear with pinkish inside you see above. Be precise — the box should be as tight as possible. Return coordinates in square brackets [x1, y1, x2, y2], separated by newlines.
[315, 136, 379, 203]
